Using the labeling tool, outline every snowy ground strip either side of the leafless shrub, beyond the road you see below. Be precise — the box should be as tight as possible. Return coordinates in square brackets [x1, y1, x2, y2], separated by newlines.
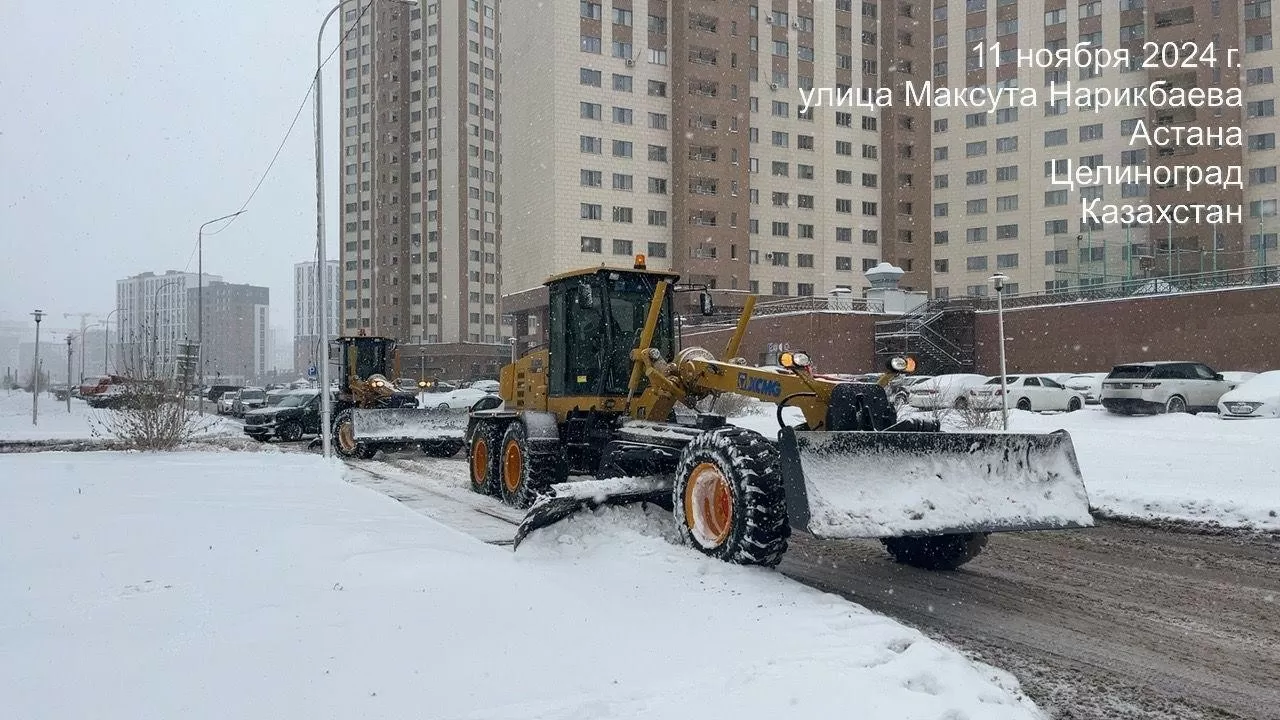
[0, 389, 241, 442]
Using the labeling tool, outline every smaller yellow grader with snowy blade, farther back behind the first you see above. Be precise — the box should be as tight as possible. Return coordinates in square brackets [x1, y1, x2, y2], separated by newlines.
[330, 336, 467, 459]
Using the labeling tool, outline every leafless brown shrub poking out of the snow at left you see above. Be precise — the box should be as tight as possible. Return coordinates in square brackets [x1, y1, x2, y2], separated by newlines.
[90, 382, 216, 450]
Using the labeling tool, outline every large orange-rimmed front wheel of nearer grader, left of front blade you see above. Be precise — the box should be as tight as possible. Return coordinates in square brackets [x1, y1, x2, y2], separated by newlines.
[672, 427, 791, 566]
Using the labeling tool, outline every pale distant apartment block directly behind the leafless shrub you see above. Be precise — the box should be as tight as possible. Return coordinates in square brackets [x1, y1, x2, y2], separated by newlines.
[115, 270, 223, 373]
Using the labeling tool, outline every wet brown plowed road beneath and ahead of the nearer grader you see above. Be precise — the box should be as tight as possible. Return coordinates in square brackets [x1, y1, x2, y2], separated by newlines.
[351, 457, 1280, 720]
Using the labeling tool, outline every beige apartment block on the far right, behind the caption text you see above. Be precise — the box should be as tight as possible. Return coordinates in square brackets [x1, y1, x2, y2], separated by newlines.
[932, 0, 1276, 297]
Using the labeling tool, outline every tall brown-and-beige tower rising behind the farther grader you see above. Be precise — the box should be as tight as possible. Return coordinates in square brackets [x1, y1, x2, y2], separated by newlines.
[340, 0, 507, 354]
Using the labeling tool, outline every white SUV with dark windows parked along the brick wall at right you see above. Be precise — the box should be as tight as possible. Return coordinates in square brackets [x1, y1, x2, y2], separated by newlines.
[1102, 360, 1234, 415]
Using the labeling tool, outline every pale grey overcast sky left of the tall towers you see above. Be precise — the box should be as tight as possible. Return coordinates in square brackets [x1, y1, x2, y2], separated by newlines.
[0, 0, 340, 333]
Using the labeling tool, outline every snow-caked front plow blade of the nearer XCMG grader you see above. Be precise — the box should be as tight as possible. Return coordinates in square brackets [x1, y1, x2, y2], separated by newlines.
[778, 428, 1093, 538]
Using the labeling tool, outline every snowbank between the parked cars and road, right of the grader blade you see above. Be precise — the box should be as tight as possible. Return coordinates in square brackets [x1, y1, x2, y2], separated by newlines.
[730, 404, 1280, 530]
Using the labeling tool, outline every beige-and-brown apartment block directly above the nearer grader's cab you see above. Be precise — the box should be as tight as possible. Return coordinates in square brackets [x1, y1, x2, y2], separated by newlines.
[502, 0, 929, 310]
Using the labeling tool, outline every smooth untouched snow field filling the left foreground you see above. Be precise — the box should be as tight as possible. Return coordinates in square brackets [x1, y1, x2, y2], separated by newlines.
[0, 452, 1041, 720]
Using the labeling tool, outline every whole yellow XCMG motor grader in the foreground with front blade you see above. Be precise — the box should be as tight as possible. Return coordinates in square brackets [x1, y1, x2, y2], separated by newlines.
[467, 256, 1092, 569]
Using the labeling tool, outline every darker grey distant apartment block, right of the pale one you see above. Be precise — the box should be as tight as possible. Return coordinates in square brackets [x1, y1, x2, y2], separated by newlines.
[187, 282, 271, 382]
